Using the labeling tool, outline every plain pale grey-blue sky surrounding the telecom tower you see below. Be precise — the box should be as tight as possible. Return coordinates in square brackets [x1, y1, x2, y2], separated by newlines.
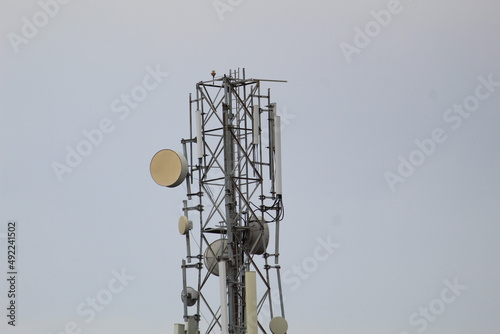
[0, 0, 500, 334]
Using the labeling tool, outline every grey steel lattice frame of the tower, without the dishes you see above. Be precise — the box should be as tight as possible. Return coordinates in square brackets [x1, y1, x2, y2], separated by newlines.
[182, 70, 285, 334]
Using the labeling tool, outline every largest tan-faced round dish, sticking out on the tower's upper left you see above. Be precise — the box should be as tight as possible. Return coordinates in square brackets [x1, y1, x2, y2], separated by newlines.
[149, 150, 188, 188]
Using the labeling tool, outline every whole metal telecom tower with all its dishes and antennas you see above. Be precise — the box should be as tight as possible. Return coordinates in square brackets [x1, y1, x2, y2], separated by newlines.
[151, 69, 288, 334]
